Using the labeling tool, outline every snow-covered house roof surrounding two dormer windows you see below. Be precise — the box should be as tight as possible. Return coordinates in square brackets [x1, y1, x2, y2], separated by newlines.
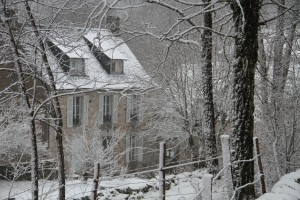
[50, 29, 149, 90]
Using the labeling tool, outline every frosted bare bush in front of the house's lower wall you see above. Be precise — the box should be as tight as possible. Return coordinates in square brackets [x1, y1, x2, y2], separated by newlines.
[66, 126, 124, 175]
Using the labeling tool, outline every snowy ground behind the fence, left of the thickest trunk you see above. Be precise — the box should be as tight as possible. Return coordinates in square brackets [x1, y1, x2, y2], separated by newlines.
[0, 171, 226, 200]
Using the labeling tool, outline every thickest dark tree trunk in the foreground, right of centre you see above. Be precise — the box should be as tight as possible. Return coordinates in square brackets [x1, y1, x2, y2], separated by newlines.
[230, 0, 259, 200]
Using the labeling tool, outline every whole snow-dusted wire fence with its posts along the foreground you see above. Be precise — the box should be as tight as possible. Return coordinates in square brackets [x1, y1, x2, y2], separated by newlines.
[1, 135, 266, 200]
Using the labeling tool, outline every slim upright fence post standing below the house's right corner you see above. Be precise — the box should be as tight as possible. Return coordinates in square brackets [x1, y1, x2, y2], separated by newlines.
[159, 142, 166, 200]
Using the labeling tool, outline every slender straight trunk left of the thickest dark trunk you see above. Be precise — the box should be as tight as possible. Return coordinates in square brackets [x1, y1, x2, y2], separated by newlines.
[202, 0, 218, 174]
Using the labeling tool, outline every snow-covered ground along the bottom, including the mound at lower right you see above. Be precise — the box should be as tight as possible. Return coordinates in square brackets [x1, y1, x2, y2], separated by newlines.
[0, 169, 300, 200]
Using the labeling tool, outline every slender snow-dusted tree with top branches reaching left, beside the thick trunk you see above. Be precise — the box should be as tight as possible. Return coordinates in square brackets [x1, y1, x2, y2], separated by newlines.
[125, 0, 221, 171]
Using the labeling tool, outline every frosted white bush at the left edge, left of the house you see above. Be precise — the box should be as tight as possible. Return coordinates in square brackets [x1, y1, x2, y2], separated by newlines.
[0, 98, 47, 179]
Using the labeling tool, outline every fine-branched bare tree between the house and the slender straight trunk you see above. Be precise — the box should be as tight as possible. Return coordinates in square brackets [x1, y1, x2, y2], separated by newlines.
[145, 44, 204, 163]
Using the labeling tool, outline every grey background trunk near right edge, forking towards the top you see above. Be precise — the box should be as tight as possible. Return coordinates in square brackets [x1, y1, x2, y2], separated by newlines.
[271, 0, 299, 177]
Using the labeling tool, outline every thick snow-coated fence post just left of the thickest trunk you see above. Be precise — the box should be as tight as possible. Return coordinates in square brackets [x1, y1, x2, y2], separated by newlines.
[221, 135, 233, 199]
